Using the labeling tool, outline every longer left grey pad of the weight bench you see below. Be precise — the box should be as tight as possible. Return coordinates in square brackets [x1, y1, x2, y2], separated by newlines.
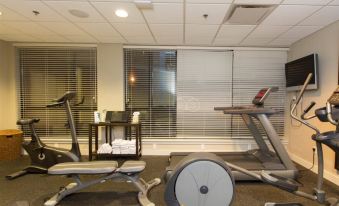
[48, 161, 118, 175]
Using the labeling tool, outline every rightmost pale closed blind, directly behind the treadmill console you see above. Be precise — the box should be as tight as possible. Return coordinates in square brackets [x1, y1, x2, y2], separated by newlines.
[232, 51, 287, 138]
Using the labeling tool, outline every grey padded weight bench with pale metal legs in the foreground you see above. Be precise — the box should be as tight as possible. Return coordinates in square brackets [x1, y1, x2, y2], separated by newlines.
[44, 161, 160, 206]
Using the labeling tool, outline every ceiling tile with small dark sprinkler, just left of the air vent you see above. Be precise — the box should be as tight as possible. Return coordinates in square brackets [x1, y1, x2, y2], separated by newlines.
[185, 4, 230, 24]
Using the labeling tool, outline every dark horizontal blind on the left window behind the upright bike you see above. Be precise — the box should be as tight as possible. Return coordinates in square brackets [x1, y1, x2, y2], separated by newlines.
[18, 47, 97, 139]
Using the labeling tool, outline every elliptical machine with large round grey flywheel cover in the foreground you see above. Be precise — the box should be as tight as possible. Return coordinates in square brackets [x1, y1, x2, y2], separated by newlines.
[165, 74, 339, 206]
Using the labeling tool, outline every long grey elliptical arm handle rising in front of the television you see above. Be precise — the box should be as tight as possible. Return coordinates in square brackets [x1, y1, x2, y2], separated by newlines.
[290, 73, 320, 135]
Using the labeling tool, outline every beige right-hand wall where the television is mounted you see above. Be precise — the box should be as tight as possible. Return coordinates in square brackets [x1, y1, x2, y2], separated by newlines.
[285, 22, 339, 184]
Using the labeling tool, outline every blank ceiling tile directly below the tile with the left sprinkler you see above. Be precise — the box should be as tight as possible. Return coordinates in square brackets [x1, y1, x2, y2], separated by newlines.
[40, 22, 84, 35]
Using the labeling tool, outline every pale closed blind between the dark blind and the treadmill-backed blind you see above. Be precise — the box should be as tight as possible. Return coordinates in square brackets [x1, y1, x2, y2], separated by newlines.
[177, 50, 233, 138]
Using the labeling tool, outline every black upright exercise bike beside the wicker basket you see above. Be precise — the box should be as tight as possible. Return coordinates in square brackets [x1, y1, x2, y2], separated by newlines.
[6, 92, 81, 180]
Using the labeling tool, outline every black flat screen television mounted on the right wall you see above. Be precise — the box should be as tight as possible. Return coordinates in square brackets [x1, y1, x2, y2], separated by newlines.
[285, 54, 318, 91]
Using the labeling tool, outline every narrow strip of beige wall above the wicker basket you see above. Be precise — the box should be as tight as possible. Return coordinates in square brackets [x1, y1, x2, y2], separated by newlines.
[0, 40, 17, 130]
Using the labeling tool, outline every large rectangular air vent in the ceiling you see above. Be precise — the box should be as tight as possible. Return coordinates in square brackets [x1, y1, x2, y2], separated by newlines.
[224, 5, 273, 25]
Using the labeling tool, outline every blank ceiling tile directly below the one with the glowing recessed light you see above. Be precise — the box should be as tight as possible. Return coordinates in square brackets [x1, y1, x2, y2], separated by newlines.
[113, 23, 152, 37]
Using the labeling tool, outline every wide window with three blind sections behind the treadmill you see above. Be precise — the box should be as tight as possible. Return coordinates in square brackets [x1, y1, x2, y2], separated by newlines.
[124, 48, 286, 139]
